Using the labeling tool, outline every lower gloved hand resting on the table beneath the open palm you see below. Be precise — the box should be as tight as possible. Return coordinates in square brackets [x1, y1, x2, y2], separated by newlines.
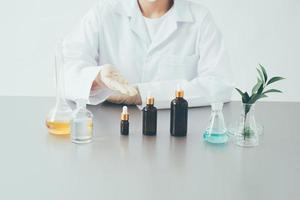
[107, 89, 142, 105]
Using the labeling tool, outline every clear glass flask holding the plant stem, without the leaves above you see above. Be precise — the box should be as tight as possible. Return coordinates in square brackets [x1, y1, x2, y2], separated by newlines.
[235, 104, 259, 147]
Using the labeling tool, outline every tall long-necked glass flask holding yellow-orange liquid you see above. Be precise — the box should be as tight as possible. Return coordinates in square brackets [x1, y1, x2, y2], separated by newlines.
[46, 40, 72, 135]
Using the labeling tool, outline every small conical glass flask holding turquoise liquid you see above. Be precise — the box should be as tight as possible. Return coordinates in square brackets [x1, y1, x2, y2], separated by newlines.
[203, 103, 229, 144]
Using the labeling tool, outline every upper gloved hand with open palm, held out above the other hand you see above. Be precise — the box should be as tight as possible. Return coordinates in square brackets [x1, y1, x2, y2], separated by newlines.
[92, 64, 138, 97]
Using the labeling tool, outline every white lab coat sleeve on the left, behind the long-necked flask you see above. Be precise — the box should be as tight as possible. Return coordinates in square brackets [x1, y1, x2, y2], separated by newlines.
[63, 6, 112, 104]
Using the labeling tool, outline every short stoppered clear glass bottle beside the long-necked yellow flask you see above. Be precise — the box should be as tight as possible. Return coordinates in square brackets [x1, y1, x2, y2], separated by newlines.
[71, 99, 94, 144]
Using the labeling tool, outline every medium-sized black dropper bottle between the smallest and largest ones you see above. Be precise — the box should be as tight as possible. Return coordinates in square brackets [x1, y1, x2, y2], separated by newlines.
[143, 95, 157, 136]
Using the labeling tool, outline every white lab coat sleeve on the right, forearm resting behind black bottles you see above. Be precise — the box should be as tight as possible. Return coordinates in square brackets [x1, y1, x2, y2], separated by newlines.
[138, 14, 233, 109]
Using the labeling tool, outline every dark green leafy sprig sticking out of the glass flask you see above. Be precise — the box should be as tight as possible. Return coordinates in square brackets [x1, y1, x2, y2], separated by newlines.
[235, 64, 285, 114]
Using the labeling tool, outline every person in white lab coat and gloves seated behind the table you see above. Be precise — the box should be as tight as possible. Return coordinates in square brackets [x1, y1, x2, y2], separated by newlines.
[63, 0, 232, 108]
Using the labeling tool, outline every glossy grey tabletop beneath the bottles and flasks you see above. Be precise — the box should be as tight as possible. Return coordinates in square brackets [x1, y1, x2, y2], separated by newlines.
[0, 97, 300, 200]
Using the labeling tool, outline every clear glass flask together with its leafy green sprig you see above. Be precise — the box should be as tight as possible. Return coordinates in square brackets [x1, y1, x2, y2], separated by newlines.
[235, 65, 284, 147]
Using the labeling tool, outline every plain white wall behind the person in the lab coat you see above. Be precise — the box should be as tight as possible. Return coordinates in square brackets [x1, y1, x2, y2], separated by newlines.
[0, 0, 300, 101]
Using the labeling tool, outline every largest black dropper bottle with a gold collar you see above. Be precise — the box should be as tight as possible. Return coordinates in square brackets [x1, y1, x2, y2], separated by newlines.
[170, 87, 188, 137]
